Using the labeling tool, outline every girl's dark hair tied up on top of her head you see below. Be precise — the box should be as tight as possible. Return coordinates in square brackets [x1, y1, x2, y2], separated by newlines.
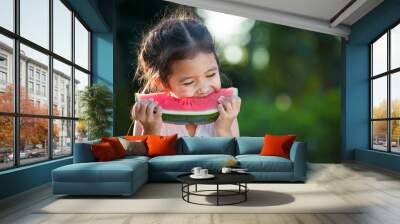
[134, 8, 227, 93]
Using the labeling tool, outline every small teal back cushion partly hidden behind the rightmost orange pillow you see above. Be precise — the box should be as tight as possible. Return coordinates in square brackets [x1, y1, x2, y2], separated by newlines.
[236, 137, 264, 155]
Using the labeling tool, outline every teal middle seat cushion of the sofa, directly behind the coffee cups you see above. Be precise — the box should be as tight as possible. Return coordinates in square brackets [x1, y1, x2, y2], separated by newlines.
[149, 154, 235, 172]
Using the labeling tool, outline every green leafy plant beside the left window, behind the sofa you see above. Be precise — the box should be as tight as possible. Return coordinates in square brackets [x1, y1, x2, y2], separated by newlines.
[79, 84, 112, 140]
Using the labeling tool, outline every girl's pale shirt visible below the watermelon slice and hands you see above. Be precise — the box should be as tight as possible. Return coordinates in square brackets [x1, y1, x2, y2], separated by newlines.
[133, 119, 239, 138]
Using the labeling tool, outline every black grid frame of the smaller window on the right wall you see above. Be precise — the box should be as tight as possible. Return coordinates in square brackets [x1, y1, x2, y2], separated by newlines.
[368, 20, 400, 155]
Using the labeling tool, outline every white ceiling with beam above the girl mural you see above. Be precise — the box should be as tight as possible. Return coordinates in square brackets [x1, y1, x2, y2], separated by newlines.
[166, 0, 383, 38]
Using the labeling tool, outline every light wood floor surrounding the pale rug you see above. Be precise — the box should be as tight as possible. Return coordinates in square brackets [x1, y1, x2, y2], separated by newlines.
[0, 163, 400, 224]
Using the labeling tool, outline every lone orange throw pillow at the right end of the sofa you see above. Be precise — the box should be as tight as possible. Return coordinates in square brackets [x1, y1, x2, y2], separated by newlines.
[260, 134, 296, 159]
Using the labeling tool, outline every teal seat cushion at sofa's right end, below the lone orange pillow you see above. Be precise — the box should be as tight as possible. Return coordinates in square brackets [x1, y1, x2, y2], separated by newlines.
[236, 155, 293, 172]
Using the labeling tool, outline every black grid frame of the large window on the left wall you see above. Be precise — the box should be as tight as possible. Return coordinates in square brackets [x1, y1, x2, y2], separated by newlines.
[0, 0, 93, 172]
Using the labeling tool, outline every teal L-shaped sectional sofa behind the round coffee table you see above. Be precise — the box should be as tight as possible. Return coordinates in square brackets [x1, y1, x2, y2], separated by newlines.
[52, 137, 307, 195]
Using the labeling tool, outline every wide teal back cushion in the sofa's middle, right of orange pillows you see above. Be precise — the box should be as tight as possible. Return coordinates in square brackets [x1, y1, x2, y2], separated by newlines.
[178, 137, 235, 155]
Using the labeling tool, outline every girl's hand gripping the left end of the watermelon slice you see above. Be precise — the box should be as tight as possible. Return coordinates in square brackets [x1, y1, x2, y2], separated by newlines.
[131, 100, 162, 135]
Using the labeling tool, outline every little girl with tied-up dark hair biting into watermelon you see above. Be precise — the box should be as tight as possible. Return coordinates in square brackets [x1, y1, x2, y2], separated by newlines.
[131, 13, 240, 137]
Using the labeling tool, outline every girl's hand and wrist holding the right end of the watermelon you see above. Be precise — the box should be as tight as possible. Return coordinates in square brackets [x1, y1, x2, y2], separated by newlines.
[215, 96, 241, 136]
